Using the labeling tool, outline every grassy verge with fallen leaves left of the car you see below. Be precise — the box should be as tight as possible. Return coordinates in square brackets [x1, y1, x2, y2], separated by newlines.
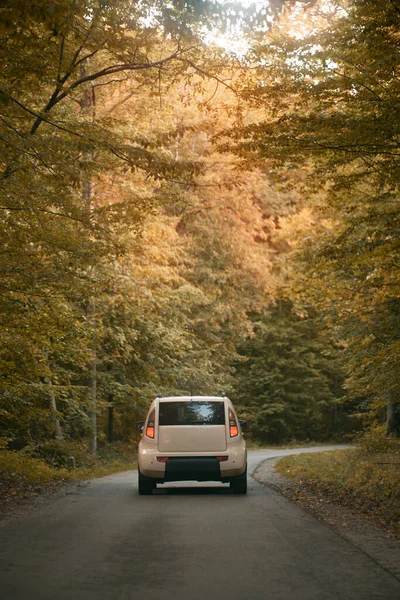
[0, 444, 137, 509]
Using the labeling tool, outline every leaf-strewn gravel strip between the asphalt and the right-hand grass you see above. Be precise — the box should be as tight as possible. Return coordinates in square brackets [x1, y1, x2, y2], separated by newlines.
[253, 458, 400, 580]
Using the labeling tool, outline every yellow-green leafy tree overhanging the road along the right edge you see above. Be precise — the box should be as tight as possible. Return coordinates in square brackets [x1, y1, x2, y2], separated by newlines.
[225, 0, 400, 434]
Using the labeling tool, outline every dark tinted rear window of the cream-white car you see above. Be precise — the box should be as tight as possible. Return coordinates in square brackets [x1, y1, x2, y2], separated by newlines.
[158, 400, 225, 425]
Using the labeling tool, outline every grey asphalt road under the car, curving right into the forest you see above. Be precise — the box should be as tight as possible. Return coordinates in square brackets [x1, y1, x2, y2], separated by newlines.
[0, 449, 400, 600]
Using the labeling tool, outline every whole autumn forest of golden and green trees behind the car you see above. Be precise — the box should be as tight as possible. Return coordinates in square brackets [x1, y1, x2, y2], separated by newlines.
[0, 0, 400, 466]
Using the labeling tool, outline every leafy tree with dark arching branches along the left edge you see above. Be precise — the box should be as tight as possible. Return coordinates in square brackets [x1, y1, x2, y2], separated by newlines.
[0, 0, 244, 444]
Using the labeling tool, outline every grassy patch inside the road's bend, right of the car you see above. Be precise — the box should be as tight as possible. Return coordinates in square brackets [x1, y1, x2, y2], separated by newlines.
[275, 430, 400, 531]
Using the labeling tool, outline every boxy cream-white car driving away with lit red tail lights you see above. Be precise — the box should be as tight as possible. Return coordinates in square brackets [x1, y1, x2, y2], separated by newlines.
[137, 396, 247, 495]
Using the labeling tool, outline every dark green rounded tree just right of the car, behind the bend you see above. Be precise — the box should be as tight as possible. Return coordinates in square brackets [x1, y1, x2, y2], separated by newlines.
[234, 300, 343, 443]
